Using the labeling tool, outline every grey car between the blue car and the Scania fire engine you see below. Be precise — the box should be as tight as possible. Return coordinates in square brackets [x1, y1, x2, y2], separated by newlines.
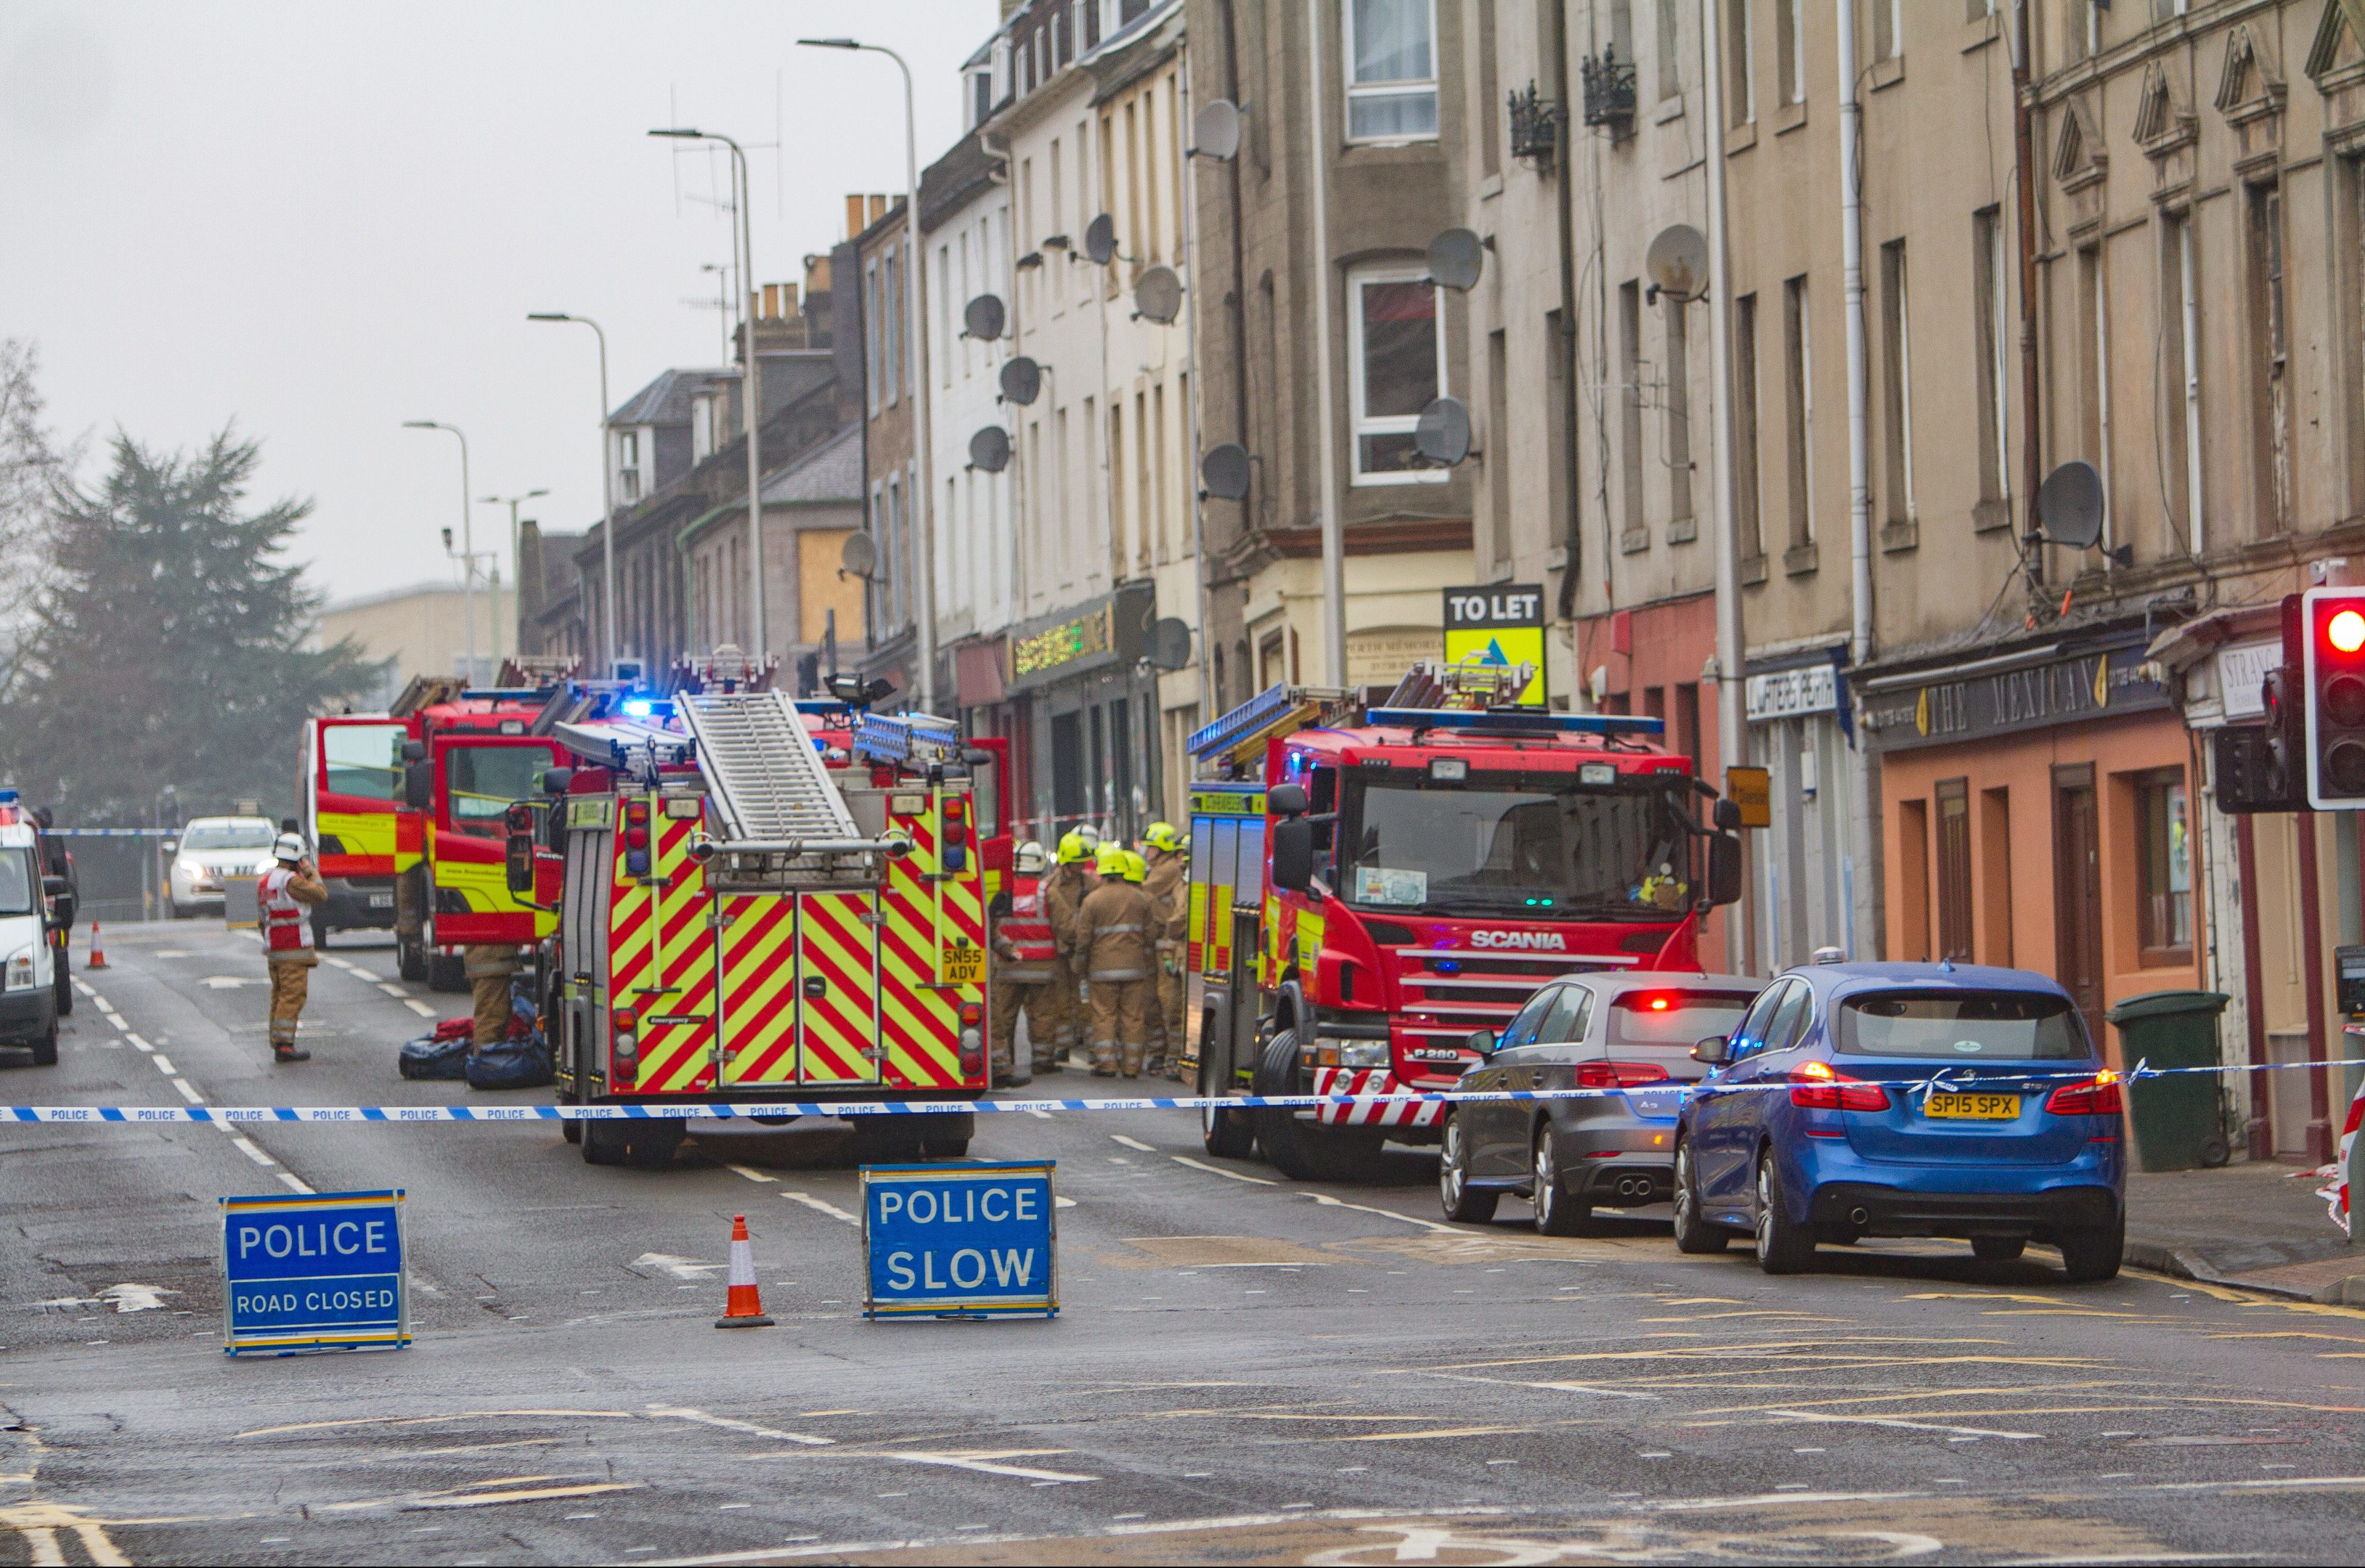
[1438, 970, 1762, 1237]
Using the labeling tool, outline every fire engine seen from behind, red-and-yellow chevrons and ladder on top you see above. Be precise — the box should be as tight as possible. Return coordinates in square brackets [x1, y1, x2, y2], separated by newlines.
[508, 690, 986, 1164]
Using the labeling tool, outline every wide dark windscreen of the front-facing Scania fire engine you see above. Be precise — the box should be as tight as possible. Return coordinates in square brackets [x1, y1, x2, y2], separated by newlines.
[1343, 773, 1693, 920]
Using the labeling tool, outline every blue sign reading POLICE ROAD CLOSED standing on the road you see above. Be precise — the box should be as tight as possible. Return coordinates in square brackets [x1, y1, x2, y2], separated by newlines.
[222, 1190, 412, 1355]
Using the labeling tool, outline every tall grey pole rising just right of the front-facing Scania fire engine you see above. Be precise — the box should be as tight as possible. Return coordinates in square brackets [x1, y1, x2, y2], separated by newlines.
[1712, 7, 1757, 972]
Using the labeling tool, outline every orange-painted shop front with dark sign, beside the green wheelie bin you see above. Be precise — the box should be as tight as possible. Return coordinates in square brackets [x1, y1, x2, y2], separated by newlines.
[1857, 622, 2207, 1060]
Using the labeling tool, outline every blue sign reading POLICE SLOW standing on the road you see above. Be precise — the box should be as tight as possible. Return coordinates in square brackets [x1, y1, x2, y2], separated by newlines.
[863, 1159, 1059, 1318]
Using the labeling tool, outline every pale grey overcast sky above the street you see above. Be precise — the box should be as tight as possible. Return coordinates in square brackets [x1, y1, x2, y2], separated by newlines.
[0, 0, 979, 598]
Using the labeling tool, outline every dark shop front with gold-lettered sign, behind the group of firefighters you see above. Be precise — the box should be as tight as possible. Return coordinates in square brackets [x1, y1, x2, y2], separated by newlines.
[1007, 584, 1161, 844]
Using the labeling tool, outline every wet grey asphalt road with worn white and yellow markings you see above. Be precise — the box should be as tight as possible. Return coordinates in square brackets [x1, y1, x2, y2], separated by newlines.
[0, 925, 2365, 1563]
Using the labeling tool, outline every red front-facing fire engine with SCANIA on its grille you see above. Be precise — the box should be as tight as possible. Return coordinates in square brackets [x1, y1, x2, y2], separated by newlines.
[1185, 664, 1741, 1177]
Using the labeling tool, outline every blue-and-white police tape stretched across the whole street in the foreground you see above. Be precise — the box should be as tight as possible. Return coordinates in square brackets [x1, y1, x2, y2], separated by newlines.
[0, 1057, 2327, 1126]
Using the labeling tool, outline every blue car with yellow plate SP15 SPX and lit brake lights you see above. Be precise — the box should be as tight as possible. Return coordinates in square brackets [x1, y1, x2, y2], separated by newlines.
[1674, 963, 2126, 1280]
